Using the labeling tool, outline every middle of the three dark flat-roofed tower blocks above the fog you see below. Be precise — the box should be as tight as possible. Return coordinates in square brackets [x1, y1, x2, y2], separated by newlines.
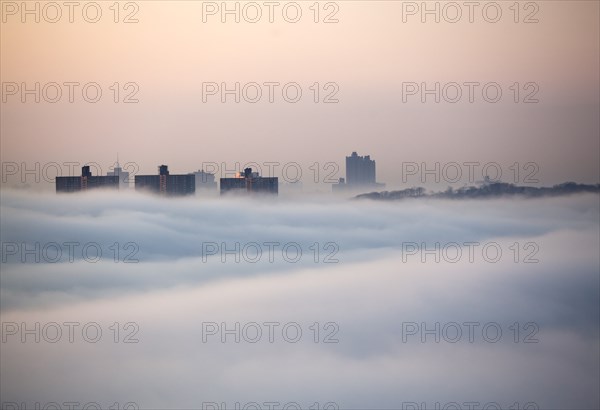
[135, 165, 196, 196]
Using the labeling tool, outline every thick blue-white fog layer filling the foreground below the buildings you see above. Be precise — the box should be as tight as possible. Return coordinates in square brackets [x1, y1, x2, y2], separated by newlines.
[0, 191, 600, 410]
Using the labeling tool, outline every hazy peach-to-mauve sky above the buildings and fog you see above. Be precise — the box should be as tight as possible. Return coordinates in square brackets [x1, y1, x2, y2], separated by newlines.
[0, 1, 600, 186]
